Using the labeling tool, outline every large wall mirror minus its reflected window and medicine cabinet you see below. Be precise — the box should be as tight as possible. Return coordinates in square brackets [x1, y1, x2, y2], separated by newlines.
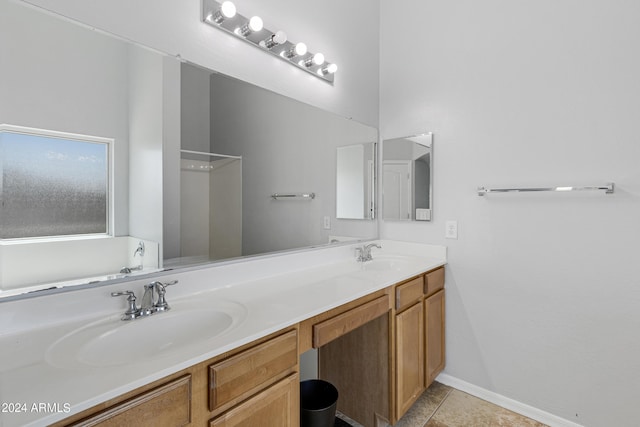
[0, 0, 378, 297]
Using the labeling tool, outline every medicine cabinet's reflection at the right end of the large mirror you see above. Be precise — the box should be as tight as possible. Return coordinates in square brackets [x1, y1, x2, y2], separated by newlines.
[336, 142, 376, 219]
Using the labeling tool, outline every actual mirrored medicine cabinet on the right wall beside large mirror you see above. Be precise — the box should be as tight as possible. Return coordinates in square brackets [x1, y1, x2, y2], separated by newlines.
[382, 133, 433, 221]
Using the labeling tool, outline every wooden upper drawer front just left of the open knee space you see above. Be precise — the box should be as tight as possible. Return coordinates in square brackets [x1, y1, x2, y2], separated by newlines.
[209, 331, 298, 411]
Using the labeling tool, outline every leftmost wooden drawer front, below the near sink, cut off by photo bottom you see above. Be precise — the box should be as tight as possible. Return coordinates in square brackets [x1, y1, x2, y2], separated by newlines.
[72, 375, 191, 427]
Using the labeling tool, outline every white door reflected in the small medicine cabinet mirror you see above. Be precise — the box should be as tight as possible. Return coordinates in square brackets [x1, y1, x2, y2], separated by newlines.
[382, 161, 412, 219]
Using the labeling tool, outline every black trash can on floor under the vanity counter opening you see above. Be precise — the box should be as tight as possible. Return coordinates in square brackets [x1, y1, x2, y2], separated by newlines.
[300, 380, 338, 427]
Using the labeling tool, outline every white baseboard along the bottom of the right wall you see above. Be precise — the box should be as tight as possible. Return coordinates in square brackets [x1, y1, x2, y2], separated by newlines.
[436, 373, 583, 427]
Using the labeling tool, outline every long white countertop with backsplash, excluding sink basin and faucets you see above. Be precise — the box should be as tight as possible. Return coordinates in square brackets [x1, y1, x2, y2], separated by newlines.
[0, 241, 446, 427]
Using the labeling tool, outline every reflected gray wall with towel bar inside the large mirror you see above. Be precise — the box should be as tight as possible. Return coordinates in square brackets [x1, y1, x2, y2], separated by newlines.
[211, 74, 377, 255]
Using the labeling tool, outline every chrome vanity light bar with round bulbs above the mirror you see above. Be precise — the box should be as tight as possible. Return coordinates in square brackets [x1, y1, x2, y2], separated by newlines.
[202, 0, 338, 84]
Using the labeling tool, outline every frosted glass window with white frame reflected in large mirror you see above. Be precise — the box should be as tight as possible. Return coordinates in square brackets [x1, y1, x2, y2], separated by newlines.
[0, 129, 109, 239]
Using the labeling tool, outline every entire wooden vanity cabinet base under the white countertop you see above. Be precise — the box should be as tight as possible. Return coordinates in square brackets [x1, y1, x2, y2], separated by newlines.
[55, 267, 445, 427]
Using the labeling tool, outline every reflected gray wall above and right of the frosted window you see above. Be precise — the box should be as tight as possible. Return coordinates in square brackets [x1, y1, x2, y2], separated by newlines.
[0, 0, 129, 235]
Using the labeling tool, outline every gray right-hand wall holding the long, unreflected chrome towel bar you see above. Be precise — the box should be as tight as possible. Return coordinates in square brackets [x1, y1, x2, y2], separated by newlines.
[380, 0, 640, 426]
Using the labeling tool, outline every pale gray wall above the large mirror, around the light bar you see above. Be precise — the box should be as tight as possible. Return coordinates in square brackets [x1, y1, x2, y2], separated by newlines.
[23, 0, 379, 126]
